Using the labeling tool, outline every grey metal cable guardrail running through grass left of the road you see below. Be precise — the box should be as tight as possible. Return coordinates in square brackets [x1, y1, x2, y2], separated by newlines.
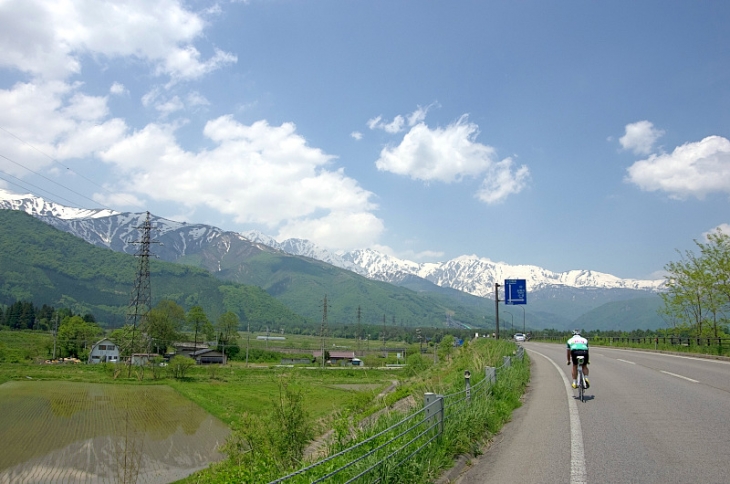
[269, 346, 524, 484]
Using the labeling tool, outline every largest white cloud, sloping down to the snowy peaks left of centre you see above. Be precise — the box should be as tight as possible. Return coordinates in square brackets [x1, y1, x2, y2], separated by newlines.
[101, 116, 383, 248]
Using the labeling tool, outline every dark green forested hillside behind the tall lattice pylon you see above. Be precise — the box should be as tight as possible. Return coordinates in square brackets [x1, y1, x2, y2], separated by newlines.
[0, 210, 312, 328]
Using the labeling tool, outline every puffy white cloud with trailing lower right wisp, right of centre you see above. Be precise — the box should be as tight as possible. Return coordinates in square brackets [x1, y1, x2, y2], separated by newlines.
[375, 115, 529, 203]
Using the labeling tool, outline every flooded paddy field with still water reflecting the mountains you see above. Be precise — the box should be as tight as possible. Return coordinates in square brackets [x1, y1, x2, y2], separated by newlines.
[0, 381, 229, 484]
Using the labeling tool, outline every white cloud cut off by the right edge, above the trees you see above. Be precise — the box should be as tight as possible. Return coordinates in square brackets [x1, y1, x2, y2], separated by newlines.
[626, 136, 730, 199]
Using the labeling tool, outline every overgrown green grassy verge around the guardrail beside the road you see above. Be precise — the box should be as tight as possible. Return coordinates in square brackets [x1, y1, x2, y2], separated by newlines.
[185, 340, 529, 484]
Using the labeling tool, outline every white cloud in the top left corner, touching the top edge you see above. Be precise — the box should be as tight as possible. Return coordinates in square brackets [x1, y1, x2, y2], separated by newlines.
[0, 0, 237, 81]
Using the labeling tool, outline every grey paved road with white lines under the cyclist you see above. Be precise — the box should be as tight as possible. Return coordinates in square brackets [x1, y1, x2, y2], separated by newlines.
[456, 343, 730, 484]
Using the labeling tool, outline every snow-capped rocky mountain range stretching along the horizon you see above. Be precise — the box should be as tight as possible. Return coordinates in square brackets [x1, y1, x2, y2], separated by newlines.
[0, 190, 664, 298]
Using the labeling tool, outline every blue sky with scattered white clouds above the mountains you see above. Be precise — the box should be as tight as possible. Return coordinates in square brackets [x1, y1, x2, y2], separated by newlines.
[0, 0, 730, 279]
